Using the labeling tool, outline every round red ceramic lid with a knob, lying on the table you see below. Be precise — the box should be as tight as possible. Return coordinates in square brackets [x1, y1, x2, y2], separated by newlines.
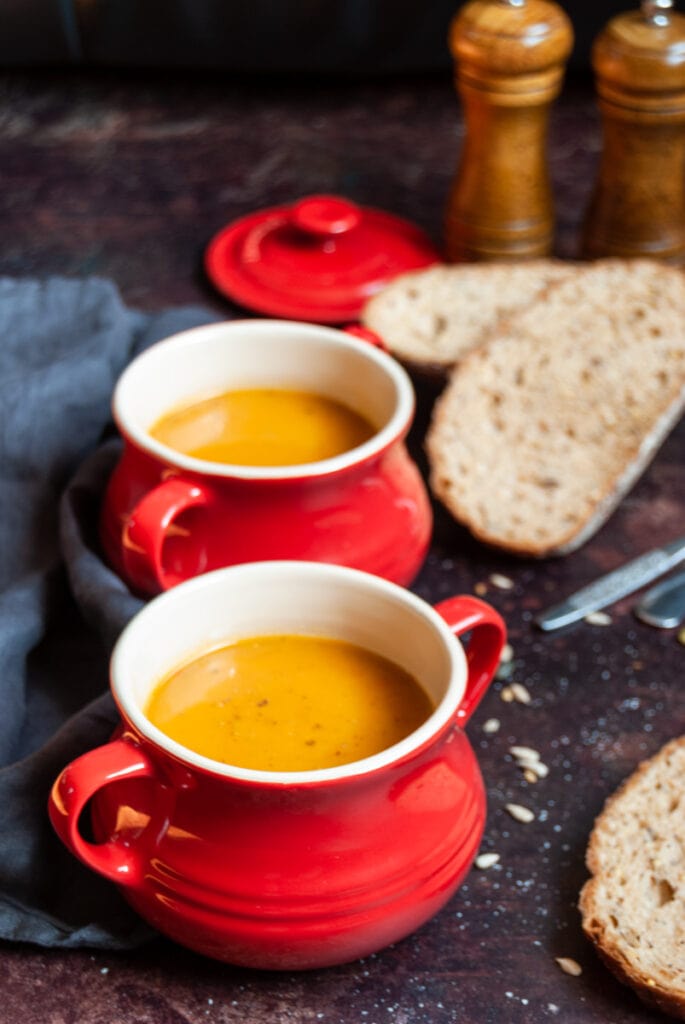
[205, 196, 440, 324]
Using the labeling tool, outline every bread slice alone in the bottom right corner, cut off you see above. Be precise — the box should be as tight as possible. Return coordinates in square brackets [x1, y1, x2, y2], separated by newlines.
[580, 736, 685, 1019]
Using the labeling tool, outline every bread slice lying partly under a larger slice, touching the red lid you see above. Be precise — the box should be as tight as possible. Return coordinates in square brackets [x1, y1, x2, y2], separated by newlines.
[361, 260, 575, 374]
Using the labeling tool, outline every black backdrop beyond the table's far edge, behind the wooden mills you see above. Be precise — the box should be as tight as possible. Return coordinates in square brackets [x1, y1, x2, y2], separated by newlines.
[0, 0, 626, 75]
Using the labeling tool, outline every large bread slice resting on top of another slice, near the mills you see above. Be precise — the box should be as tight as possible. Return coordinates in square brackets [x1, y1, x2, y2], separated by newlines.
[426, 260, 685, 557]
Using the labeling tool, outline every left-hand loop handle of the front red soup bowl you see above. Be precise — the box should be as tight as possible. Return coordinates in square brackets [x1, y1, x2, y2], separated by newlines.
[48, 739, 158, 887]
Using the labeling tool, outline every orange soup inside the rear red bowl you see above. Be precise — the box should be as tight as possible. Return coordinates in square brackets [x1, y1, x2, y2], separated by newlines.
[148, 388, 376, 466]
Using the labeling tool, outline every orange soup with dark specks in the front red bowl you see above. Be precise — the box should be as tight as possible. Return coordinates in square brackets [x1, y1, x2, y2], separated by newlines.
[145, 636, 433, 771]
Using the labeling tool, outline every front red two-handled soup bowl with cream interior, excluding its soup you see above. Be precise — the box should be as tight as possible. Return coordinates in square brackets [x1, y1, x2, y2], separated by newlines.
[49, 561, 505, 970]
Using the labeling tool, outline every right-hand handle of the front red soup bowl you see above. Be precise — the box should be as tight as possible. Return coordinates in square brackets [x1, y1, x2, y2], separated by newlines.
[435, 594, 507, 726]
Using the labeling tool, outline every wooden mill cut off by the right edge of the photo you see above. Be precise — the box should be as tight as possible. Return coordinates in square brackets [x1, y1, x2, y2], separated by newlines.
[582, 0, 685, 263]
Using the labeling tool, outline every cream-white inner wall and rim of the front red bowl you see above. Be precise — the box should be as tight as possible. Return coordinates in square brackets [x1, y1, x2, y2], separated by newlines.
[112, 562, 466, 777]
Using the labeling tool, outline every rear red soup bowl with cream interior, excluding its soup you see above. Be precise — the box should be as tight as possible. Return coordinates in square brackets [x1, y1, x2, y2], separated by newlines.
[100, 319, 432, 595]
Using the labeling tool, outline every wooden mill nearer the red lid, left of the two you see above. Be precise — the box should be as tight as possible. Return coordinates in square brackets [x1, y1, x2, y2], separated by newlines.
[445, 0, 573, 260]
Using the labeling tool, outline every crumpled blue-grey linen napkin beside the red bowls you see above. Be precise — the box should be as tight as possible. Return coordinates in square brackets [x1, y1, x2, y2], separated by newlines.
[0, 278, 216, 948]
